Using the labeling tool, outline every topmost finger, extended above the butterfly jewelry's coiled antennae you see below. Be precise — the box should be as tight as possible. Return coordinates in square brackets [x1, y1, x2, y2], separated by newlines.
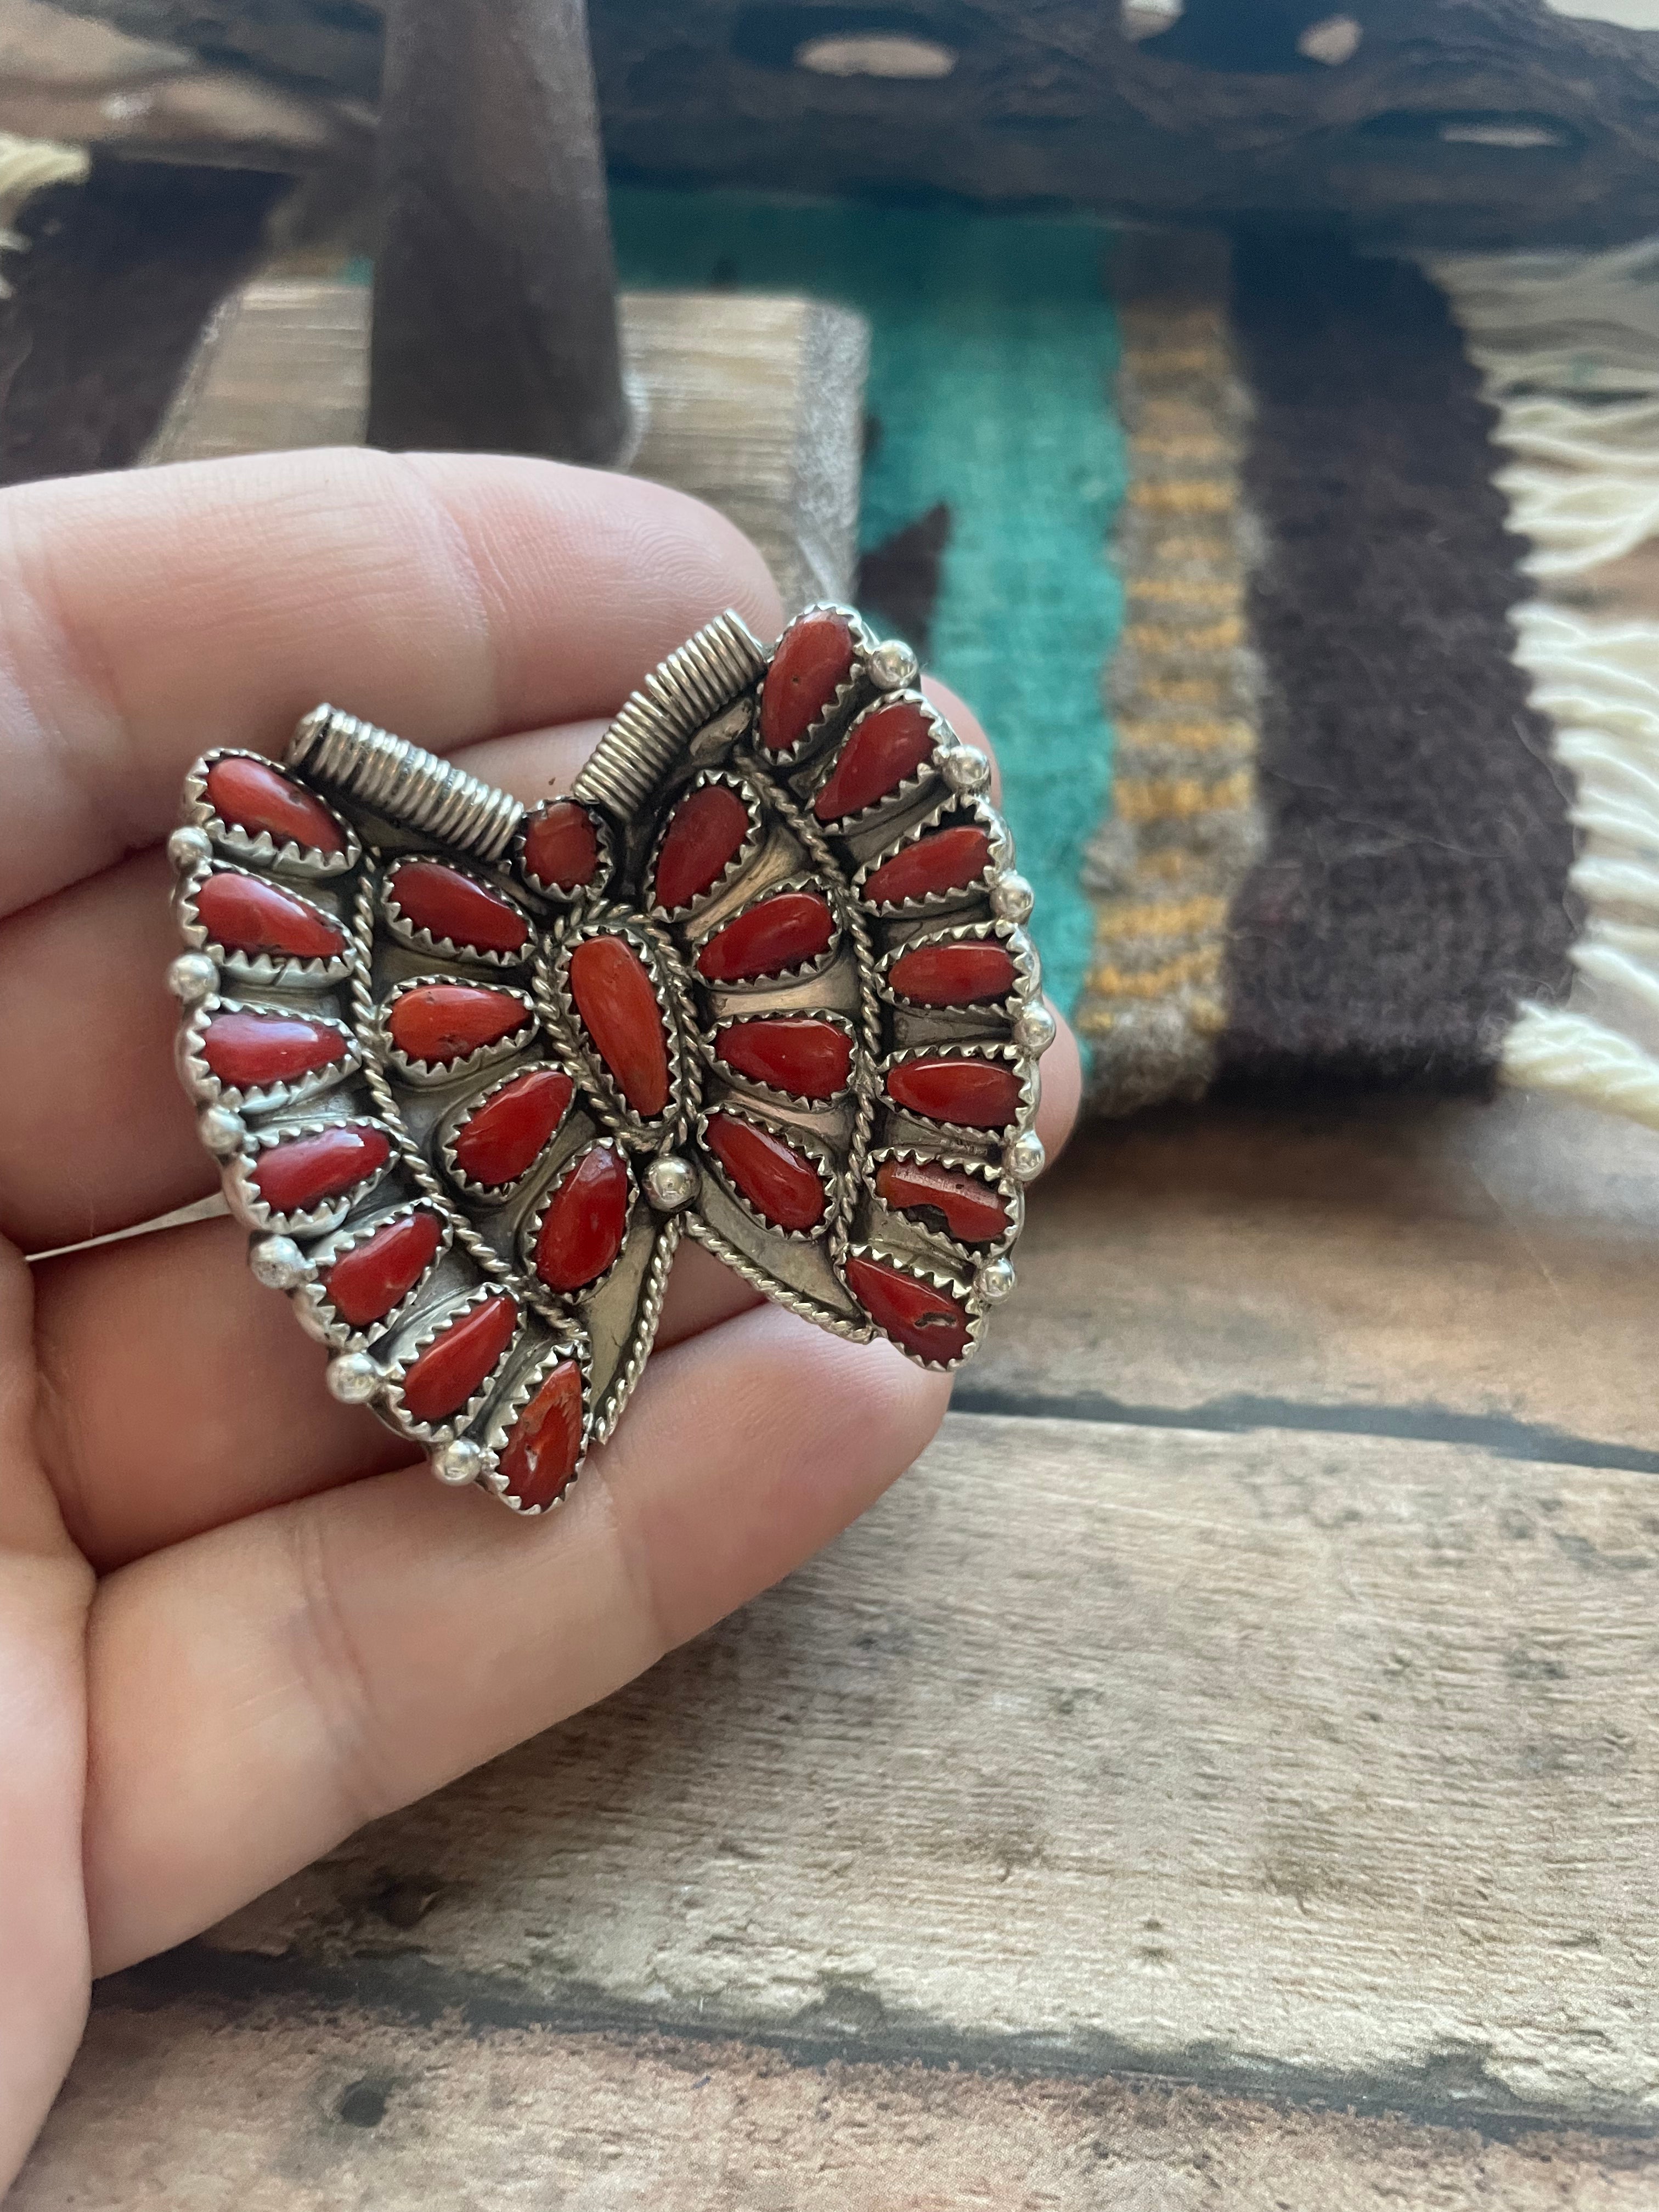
[0, 449, 778, 911]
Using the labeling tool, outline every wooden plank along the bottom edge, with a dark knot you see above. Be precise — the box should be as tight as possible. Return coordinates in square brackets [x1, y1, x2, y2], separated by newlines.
[9, 2006, 1655, 2212]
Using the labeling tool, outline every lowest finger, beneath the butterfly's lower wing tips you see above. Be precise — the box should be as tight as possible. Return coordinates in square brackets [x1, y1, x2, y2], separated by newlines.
[86, 1310, 947, 1973]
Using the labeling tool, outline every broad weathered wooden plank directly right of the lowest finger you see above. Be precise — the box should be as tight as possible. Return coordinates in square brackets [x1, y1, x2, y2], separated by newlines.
[179, 1415, 1659, 2128]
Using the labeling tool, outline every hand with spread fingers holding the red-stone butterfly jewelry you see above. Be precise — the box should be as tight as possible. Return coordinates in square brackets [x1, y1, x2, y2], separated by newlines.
[0, 454, 1077, 2188]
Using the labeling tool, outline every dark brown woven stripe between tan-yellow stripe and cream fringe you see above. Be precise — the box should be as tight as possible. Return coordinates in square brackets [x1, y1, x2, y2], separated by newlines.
[1219, 232, 1573, 1091]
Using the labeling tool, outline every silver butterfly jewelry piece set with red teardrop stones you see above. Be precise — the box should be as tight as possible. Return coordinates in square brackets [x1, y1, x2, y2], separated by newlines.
[170, 608, 1053, 1513]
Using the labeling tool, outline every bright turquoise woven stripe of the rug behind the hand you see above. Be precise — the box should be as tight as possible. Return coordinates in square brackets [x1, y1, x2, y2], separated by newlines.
[611, 186, 1124, 1007]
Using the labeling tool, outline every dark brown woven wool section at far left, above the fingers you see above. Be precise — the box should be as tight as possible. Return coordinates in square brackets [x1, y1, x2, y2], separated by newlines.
[0, 161, 287, 484]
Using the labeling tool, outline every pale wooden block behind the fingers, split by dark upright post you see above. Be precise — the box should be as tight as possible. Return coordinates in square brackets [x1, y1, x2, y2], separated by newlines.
[148, 276, 870, 606]
